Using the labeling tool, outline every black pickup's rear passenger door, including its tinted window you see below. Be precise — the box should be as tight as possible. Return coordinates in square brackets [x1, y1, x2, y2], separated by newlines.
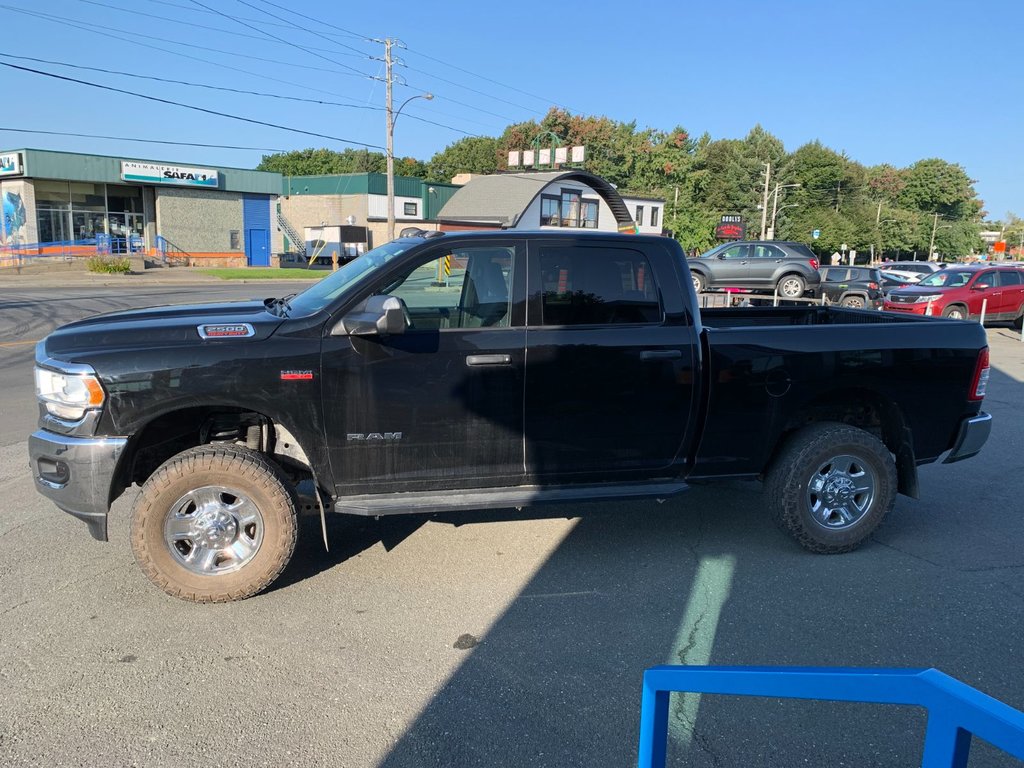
[525, 239, 697, 482]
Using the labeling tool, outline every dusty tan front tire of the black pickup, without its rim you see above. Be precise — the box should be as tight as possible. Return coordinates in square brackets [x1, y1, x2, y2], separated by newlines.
[131, 445, 298, 602]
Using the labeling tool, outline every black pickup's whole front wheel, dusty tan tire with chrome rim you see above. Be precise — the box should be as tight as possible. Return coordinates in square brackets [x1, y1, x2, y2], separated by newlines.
[131, 445, 298, 602]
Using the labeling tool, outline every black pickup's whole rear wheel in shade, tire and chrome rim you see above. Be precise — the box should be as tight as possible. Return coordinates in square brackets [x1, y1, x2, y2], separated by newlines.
[765, 422, 896, 554]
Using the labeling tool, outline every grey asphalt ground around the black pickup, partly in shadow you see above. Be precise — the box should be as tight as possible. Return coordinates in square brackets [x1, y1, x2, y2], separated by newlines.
[0, 276, 1024, 768]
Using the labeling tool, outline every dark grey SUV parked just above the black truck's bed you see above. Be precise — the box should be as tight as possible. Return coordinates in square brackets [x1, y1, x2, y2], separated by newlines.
[688, 241, 821, 299]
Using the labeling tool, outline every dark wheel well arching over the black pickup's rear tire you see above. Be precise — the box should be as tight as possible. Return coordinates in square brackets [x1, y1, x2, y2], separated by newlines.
[771, 389, 918, 498]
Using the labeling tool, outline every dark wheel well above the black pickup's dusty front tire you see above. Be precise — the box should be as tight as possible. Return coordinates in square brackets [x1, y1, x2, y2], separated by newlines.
[122, 407, 311, 487]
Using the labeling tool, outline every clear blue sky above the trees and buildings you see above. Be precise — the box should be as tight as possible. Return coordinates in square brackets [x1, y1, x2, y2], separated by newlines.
[0, 0, 1024, 218]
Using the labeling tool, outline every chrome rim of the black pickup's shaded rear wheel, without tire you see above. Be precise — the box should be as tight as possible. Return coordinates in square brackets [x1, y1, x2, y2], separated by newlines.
[807, 455, 878, 530]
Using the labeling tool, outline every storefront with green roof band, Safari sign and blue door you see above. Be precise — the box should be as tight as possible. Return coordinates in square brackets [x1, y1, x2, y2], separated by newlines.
[0, 150, 282, 266]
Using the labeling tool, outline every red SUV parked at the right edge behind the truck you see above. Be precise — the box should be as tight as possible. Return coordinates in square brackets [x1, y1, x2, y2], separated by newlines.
[883, 264, 1024, 328]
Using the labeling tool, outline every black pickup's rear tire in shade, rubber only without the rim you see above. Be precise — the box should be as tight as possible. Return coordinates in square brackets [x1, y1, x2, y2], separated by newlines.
[765, 422, 897, 554]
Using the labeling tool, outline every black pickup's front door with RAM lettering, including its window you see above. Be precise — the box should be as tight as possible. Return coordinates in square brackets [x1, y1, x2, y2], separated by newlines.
[323, 239, 525, 494]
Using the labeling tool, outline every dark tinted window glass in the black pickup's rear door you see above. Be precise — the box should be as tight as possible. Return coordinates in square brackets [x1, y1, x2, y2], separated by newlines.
[530, 246, 662, 326]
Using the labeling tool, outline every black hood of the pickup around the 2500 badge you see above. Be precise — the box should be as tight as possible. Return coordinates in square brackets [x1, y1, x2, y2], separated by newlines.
[45, 301, 284, 359]
